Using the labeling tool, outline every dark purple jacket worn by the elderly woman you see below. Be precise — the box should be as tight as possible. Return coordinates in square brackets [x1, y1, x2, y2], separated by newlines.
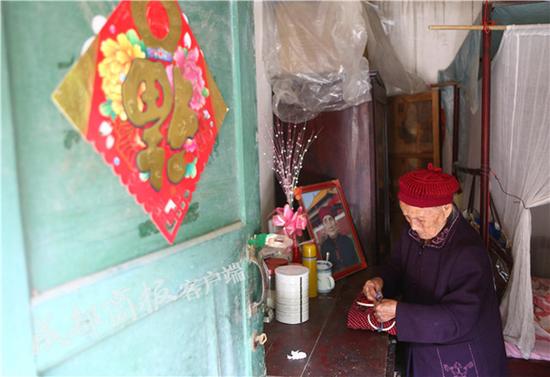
[380, 209, 507, 377]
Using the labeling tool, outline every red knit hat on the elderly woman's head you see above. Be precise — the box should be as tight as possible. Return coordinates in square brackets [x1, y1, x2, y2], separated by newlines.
[397, 163, 459, 208]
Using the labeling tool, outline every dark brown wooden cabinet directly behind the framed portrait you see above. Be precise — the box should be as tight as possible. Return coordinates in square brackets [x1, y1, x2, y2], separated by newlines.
[299, 72, 390, 265]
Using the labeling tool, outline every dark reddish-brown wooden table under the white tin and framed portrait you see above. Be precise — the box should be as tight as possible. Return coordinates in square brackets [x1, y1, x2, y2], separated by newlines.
[265, 271, 395, 377]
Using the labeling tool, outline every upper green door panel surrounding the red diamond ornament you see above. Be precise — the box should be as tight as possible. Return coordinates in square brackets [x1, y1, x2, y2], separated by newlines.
[5, 2, 244, 291]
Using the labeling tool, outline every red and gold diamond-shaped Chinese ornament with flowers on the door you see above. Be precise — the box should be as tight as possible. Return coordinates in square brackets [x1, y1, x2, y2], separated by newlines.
[52, 1, 227, 243]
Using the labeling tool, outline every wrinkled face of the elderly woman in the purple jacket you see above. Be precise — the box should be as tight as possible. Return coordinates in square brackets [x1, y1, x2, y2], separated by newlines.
[399, 202, 453, 240]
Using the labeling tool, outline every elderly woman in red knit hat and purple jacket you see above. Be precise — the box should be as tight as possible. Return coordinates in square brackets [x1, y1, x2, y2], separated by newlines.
[363, 164, 507, 377]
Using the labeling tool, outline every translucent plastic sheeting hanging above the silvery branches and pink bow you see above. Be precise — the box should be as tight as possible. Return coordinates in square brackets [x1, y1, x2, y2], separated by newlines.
[263, 2, 370, 123]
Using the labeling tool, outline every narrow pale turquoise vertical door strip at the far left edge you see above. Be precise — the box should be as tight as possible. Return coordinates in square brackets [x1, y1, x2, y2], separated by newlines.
[0, 25, 35, 376]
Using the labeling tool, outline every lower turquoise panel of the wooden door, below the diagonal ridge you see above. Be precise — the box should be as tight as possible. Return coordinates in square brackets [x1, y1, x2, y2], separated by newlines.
[32, 223, 246, 375]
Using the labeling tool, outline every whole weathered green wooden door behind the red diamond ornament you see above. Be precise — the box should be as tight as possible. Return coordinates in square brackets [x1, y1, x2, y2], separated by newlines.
[1, 1, 265, 376]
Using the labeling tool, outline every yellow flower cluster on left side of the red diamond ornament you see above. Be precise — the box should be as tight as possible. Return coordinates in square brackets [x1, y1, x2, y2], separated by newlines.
[98, 30, 145, 120]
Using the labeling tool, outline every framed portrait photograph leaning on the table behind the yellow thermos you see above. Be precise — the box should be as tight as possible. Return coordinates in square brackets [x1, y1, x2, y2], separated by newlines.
[297, 180, 367, 279]
